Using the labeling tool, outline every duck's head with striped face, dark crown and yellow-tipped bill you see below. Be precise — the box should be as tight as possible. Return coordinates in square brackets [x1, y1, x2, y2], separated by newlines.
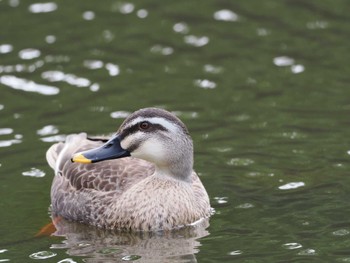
[72, 108, 193, 180]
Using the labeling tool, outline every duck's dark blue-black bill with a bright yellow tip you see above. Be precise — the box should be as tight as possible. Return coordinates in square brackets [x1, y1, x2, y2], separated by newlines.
[72, 136, 130, 163]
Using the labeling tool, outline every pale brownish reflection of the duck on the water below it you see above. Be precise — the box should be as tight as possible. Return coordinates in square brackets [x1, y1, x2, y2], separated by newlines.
[51, 219, 209, 262]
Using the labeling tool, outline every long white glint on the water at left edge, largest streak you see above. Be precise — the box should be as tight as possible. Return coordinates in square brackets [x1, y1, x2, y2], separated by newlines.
[0, 75, 60, 95]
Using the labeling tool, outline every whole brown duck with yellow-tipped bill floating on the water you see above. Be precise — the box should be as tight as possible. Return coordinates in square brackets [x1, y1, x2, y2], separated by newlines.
[46, 108, 212, 231]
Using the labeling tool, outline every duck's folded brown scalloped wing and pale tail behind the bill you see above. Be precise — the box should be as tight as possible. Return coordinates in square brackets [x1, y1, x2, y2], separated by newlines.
[46, 133, 154, 192]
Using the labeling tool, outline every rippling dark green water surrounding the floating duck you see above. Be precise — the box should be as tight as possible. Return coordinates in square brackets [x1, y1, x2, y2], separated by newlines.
[0, 0, 350, 263]
